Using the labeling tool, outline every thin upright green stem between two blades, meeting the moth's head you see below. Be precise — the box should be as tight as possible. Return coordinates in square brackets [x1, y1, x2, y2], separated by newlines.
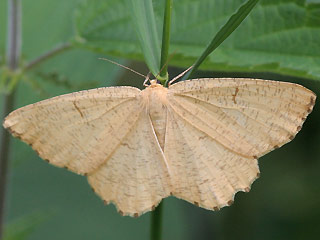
[158, 0, 172, 85]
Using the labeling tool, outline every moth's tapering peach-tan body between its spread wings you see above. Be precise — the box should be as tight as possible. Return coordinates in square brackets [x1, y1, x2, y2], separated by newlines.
[142, 84, 168, 149]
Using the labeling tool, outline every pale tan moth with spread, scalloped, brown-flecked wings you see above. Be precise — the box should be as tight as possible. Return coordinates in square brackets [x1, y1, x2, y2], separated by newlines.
[3, 75, 316, 217]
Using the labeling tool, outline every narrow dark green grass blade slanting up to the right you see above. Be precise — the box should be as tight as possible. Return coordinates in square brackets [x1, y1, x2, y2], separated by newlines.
[183, 0, 259, 79]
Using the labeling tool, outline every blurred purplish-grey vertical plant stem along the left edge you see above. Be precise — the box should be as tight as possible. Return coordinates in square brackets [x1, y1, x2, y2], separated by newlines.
[0, 0, 21, 239]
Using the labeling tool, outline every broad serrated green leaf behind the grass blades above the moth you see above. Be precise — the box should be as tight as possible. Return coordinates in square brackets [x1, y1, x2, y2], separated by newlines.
[75, 0, 320, 79]
